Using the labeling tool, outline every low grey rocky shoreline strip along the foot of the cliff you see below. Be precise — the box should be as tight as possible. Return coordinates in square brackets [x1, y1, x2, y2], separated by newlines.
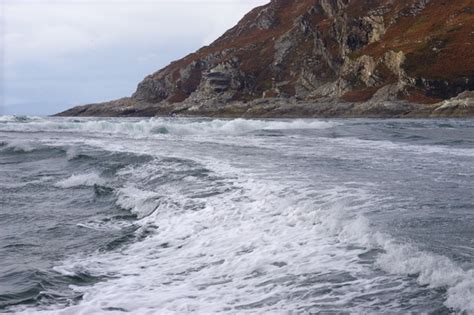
[52, 92, 474, 119]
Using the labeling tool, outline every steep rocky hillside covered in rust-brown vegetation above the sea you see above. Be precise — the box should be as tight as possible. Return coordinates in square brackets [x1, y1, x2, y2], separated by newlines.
[61, 0, 474, 116]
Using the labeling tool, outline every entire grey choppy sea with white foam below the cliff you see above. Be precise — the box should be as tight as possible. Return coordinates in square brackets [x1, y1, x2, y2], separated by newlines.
[0, 116, 474, 314]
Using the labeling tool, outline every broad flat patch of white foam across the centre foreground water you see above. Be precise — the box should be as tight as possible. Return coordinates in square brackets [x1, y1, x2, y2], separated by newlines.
[29, 168, 418, 314]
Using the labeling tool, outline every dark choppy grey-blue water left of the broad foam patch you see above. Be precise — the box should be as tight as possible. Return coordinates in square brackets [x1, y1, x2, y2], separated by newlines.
[0, 146, 161, 312]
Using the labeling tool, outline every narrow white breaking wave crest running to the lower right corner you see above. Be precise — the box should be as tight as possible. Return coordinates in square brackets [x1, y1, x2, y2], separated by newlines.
[312, 196, 474, 314]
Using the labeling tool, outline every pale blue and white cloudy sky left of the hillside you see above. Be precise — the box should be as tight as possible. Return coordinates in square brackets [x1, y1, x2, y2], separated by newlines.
[0, 0, 269, 115]
